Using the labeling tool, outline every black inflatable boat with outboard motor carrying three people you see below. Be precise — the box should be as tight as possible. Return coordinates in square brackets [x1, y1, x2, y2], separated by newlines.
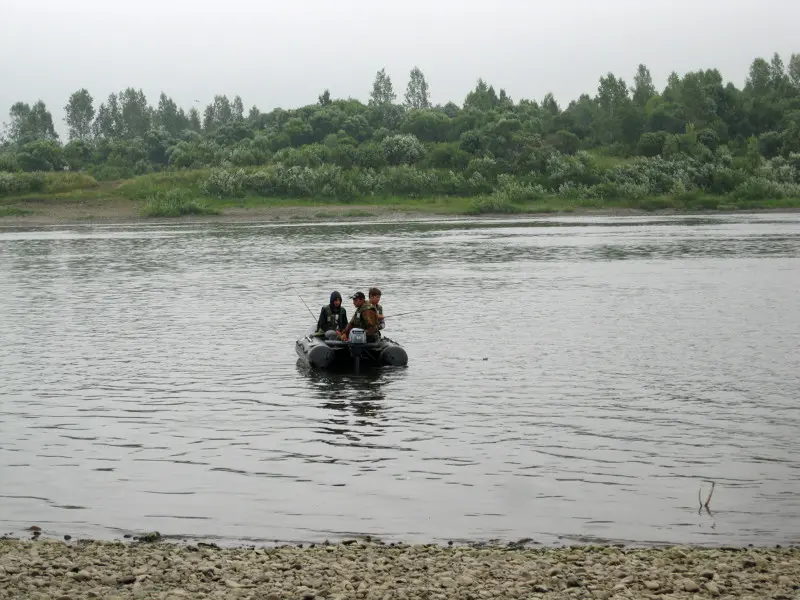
[295, 329, 408, 371]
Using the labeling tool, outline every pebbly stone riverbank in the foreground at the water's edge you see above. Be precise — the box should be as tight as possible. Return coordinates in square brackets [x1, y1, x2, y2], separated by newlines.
[0, 539, 800, 600]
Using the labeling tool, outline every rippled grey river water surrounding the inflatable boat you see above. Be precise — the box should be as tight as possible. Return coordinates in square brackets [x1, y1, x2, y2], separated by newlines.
[0, 214, 800, 544]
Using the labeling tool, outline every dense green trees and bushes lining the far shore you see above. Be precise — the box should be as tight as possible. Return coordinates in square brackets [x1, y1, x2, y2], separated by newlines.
[0, 54, 800, 206]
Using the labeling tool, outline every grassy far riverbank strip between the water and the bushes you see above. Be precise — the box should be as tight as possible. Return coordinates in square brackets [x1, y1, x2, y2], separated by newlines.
[0, 171, 800, 226]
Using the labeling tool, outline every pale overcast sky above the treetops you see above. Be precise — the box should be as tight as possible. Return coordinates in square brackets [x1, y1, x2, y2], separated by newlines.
[0, 0, 800, 136]
